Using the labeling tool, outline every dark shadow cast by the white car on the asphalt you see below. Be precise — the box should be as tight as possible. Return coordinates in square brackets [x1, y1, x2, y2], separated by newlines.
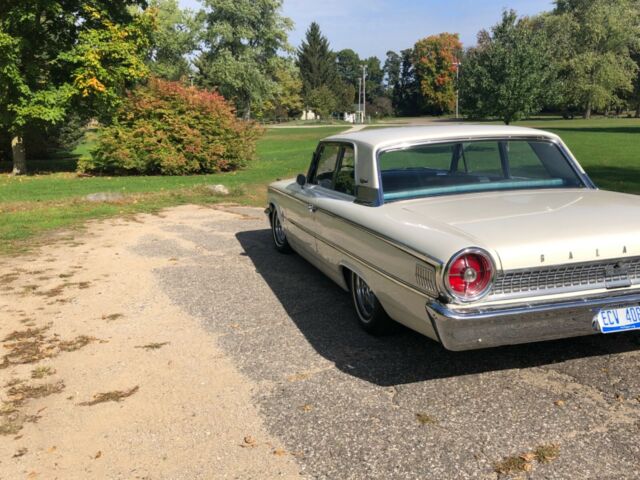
[236, 229, 640, 386]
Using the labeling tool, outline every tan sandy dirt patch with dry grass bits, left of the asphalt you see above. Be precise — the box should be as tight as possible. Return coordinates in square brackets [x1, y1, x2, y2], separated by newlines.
[0, 207, 300, 479]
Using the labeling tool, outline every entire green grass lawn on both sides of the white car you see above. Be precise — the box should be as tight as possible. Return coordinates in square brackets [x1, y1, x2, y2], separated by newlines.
[0, 118, 640, 253]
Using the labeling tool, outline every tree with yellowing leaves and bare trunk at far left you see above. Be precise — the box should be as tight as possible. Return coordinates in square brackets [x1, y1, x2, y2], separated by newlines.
[0, 0, 153, 174]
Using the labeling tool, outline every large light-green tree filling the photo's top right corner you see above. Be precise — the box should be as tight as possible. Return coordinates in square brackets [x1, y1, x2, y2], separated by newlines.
[553, 0, 640, 118]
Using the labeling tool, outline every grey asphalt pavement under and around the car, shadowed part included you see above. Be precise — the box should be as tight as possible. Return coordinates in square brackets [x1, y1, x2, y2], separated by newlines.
[152, 208, 640, 479]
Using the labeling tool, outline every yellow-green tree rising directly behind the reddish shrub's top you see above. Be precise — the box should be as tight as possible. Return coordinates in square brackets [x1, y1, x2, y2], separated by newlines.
[149, 0, 204, 80]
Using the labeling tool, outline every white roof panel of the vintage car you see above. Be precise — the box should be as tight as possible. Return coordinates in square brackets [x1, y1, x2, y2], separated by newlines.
[323, 124, 558, 150]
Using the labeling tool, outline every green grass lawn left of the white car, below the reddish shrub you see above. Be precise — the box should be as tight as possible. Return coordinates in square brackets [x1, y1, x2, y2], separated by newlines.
[0, 127, 344, 253]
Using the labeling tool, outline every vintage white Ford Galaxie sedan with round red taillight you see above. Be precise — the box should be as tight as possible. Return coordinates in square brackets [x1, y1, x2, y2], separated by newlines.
[266, 125, 640, 350]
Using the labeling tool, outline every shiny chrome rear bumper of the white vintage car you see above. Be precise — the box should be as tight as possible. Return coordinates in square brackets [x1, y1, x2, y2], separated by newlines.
[426, 292, 640, 350]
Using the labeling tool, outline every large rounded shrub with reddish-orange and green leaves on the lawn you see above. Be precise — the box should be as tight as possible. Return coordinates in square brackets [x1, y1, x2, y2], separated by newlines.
[78, 79, 261, 175]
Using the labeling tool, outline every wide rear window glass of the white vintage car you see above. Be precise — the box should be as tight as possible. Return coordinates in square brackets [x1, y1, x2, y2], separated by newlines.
[379, 139, 585, 202]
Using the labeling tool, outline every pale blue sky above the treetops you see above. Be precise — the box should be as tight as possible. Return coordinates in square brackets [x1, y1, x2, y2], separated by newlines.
[179, 0, 553, 61]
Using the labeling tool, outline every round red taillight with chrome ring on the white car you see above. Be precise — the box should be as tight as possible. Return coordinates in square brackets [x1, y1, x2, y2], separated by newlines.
[444, 250, 494, 301]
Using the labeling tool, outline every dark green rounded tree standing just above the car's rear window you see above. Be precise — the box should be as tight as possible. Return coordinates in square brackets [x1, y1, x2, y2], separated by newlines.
[460, 10, 555, 124]
